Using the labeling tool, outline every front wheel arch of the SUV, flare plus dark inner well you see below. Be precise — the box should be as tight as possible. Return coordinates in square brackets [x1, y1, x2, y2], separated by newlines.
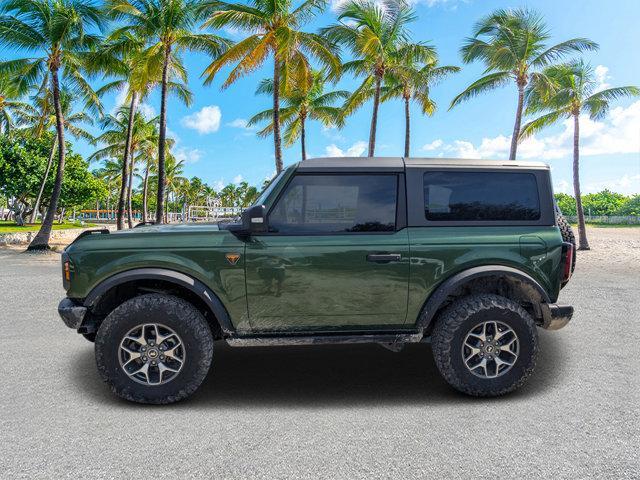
[83, 268, 235, 336]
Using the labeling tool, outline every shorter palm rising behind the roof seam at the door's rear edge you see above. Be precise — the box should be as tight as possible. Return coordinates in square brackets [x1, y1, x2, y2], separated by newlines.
[380, 44, 460, 157]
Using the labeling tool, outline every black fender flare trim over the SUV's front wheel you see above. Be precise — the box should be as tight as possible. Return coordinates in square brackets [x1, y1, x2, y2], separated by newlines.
[83, 268, 235, 335]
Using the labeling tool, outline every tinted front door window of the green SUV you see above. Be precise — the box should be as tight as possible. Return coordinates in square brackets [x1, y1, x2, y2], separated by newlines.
[269, 175, 398, 233]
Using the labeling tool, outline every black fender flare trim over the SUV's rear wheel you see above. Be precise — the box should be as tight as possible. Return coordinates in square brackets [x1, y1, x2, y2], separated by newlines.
[416, 265, 551, 330]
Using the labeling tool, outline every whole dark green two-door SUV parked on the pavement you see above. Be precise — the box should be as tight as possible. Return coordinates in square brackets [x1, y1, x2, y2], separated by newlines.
[58, 158, 575, 403]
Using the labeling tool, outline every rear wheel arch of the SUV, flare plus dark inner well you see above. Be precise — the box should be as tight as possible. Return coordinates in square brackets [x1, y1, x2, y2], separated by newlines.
[416, 265, 551, 333]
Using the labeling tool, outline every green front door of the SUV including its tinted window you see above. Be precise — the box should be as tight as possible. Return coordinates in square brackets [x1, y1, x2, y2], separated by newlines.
[245, 173, 409, 331]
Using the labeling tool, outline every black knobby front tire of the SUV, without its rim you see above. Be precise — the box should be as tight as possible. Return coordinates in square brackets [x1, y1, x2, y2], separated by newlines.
[95, 293, 213, 404]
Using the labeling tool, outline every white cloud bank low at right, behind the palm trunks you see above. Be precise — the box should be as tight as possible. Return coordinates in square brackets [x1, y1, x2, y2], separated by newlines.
[422, 101, 640, 160]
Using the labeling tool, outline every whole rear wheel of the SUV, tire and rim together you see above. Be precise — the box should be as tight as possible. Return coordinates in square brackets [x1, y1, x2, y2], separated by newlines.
[432, 294, 538, 397]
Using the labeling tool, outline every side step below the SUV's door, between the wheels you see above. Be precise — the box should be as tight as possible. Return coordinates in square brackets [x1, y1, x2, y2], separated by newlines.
[226, 332, 422, 347]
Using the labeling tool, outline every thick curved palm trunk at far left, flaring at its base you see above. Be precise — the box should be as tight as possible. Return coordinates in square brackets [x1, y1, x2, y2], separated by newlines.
[27, 67, 65, 250]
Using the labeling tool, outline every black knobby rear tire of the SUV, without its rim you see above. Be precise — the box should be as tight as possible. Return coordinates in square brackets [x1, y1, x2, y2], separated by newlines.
[431, 294, 538, 397]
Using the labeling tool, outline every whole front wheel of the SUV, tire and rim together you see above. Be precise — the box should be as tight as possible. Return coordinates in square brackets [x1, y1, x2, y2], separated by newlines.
[96, 293, 213, 404]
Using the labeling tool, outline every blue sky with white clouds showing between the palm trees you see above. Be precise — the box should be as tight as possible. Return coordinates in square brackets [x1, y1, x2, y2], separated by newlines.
[6, 0, 640, 193]
